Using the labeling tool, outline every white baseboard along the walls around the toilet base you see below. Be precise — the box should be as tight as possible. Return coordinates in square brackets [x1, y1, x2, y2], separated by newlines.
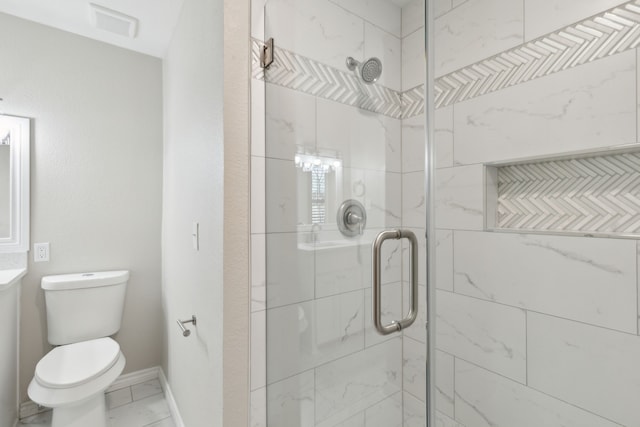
[19, 366, 185, 427]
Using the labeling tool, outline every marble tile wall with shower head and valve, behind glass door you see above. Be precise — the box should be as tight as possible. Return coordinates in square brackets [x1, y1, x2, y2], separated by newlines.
[251, 0, 412, 427]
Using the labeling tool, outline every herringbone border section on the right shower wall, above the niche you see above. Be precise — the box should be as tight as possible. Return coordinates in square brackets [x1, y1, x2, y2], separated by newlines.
[435, 0, 640, 108]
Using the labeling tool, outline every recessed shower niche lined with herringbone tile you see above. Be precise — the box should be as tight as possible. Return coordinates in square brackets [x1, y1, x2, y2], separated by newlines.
[485, 144, 640, 239]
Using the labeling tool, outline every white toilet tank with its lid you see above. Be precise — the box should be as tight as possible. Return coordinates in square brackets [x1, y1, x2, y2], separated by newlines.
[41, 271, 129, 345]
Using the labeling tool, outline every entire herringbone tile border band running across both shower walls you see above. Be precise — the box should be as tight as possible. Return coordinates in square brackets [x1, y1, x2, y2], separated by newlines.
[252, 0, 640, 118]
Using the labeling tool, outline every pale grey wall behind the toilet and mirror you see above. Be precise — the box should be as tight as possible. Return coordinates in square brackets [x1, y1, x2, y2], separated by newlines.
[0, 14, 162, 399]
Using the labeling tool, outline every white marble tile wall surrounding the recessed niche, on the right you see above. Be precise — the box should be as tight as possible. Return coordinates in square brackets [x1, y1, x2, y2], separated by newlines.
[438, 0, 640, 427]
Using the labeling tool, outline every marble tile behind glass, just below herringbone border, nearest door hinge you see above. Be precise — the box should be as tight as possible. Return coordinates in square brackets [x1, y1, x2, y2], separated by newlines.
[265, 84, 316, 160]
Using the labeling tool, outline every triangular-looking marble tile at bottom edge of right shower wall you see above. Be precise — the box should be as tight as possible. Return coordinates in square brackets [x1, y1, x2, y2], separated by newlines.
[455, 360, 618, 427]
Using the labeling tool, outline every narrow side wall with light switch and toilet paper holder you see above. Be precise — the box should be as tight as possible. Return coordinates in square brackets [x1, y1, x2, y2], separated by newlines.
[162, 0, 224, 427]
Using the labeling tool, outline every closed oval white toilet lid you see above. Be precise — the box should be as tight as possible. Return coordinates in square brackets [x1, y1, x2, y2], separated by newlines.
[35, 338, 120, 388]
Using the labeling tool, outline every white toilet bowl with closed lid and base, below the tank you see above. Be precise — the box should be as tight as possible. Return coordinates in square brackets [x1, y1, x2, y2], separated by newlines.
[28, 338, 125, 427]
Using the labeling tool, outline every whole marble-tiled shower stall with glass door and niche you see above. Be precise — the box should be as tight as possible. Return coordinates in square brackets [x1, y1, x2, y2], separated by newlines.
[251, 0, 640, 427]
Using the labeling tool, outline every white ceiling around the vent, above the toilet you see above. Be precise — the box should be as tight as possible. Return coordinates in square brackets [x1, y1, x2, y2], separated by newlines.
[0, 0, 184, 57]
